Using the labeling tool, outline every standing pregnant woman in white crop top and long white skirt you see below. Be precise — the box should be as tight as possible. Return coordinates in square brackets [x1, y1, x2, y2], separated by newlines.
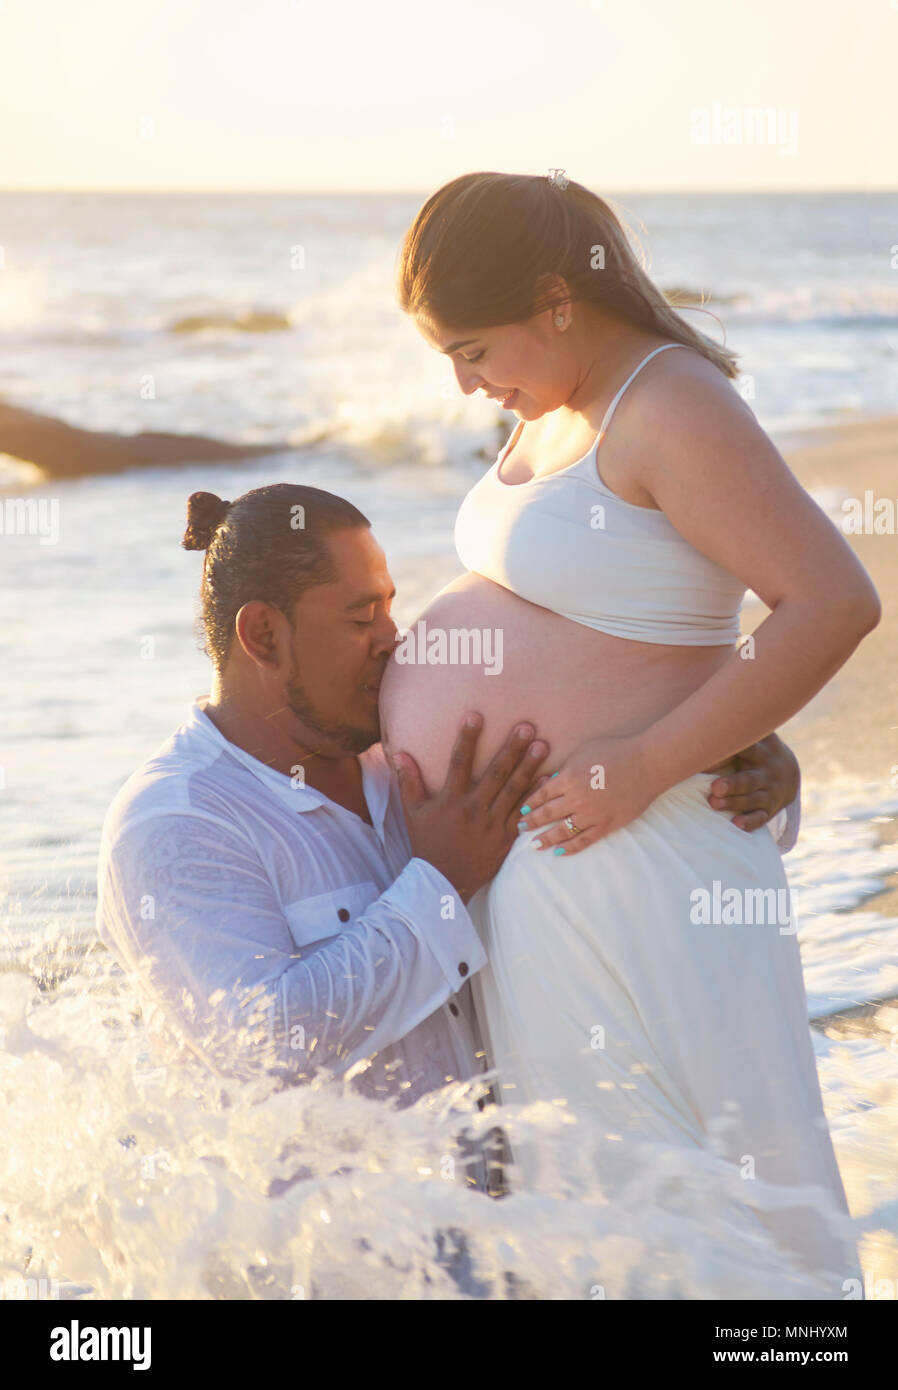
[381, 172, 880, 1279]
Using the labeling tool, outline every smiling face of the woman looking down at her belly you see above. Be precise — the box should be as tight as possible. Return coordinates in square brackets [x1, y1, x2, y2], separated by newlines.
[416, 310, 578, 420]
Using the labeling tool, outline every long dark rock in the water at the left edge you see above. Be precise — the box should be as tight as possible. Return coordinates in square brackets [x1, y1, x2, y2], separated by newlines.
[0, 402, 289, 478]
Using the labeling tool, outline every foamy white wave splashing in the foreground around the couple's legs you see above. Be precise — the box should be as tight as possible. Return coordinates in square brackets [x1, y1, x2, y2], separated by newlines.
[0, 970, 867, 1301]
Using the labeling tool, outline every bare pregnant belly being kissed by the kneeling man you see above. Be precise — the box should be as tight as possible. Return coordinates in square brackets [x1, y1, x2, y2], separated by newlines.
[379, 573, 731, 792]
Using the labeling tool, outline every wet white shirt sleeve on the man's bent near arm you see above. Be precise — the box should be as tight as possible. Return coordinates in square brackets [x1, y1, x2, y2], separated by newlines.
[97, 812, 487, 1081]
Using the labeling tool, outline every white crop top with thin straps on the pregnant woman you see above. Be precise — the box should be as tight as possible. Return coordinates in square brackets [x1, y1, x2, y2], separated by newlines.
[455, 343, 745, 646]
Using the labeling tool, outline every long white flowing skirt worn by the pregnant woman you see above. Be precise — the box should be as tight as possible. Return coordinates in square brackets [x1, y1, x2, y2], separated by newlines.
[468, 773, 856, 1287]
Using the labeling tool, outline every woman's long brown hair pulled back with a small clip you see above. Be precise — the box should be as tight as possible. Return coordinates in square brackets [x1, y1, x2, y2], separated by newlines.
[398, 174, 738, 377]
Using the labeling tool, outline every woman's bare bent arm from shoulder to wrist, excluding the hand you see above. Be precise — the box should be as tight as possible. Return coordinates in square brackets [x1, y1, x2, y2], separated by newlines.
[639, 373, 881, 788]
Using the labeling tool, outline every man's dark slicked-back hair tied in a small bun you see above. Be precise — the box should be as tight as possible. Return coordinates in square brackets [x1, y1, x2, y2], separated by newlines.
[181, 482, 371, 671]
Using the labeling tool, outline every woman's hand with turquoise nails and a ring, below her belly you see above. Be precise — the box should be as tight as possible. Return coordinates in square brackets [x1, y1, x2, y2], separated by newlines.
[519, 735, 664, 855]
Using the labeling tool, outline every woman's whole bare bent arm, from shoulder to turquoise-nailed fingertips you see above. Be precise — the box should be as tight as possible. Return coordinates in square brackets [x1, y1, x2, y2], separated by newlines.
[519, 364, 880, 852]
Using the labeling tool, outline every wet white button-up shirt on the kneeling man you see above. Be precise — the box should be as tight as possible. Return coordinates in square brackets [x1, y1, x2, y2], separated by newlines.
[97, 701, 487, 1104]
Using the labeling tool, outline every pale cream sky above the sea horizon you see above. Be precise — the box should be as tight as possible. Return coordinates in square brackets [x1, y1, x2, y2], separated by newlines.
[0, 0, 898, 192]
